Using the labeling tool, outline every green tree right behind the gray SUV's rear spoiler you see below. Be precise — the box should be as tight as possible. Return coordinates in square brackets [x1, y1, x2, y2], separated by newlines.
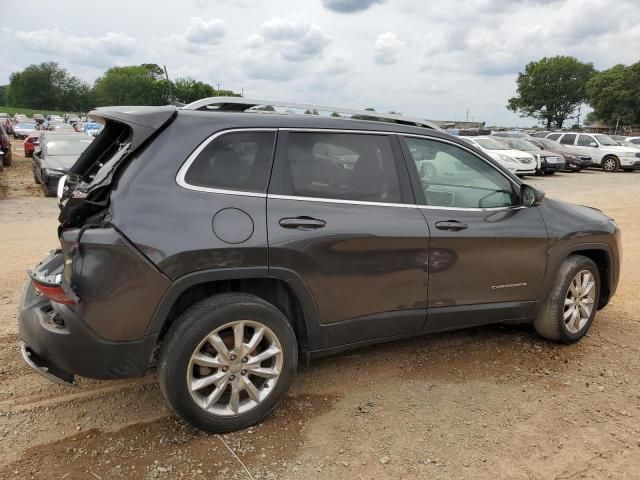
[93, 63, 171, 105]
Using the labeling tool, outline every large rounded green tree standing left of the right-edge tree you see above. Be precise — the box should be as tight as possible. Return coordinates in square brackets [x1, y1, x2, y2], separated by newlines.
[507, 55, 595, 129]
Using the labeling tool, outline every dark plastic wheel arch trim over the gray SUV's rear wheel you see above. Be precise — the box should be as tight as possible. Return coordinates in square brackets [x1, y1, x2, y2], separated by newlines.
[146, 267, 327, 360]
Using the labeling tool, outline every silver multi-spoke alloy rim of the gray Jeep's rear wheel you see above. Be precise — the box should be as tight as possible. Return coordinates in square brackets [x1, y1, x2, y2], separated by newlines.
[187, 320, 283, 416]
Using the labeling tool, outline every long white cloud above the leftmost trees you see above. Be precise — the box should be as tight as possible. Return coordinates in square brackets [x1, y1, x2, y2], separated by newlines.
[16, 28, 136, 67]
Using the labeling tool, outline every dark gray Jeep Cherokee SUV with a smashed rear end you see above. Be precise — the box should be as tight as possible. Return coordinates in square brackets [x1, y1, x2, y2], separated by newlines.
[19, 98, 621, 432]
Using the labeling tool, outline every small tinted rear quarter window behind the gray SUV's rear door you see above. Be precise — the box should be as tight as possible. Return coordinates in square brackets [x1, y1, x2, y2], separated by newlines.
[184, 132, 275, 192]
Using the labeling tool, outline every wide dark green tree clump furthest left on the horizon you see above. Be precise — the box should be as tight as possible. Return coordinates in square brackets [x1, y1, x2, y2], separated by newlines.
[6, 62, 89, 110]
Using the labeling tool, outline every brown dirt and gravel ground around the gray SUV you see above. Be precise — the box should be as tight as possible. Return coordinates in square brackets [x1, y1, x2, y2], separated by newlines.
[0, 136, 640, 479]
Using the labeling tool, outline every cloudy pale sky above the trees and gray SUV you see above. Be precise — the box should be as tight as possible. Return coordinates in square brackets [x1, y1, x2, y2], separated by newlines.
[0, 0, 640, 125]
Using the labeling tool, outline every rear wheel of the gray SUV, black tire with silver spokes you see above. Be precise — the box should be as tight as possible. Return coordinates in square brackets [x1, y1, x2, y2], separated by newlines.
[158, 293, 298, 433]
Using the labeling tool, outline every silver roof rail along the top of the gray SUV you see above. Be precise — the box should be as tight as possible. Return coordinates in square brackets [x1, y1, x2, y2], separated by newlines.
[182, 97, 441, 130]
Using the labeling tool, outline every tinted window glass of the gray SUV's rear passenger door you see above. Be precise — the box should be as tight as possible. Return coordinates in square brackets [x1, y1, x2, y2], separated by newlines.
[280, 132, 401, 203]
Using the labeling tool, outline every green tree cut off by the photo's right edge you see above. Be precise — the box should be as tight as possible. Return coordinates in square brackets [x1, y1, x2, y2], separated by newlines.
[587, 62, 640, 125]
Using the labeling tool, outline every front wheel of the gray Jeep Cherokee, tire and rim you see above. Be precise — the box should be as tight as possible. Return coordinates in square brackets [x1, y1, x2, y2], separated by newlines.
[534, 255, 600, 343]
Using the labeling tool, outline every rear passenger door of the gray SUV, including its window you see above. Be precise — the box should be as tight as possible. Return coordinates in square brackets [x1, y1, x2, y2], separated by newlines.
[267, 130, 428, 349]
